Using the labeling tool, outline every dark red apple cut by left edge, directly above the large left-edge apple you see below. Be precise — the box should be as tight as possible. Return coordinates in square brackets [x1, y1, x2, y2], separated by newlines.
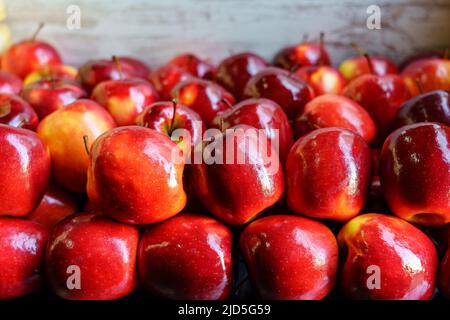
[0, 93, 39, 131]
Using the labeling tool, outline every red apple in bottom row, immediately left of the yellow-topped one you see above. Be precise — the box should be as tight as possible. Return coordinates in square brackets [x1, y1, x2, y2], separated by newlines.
[239, 215, 338, 300]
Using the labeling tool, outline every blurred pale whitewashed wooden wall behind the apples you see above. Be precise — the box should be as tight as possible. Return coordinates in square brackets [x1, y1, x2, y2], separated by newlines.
[4, 0, 450, 66]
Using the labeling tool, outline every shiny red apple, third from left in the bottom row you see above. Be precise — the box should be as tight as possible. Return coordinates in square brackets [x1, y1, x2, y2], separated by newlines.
[138, 213, 233, 300]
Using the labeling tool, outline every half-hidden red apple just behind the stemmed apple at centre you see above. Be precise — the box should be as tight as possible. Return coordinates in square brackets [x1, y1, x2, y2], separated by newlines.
[171, 79, 235, 127]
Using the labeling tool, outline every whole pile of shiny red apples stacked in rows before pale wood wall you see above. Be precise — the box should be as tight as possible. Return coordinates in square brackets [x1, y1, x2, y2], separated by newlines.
[0, 26, 450, 300]
